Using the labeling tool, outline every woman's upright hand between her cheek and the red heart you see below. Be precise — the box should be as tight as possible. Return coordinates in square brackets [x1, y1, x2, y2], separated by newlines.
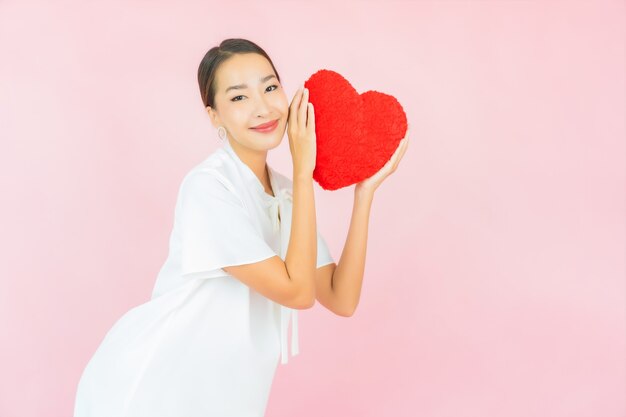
[287, 86, 317, 178]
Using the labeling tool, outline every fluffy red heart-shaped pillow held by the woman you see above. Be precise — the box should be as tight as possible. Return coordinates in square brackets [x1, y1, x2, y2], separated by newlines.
[304, 69, 407, 190]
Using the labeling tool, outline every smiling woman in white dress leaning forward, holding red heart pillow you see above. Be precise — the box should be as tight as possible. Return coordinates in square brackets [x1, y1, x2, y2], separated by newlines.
[74, 39, 407, 417]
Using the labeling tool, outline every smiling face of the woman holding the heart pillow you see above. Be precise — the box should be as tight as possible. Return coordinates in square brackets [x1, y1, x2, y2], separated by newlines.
[207, 53, 289, 151]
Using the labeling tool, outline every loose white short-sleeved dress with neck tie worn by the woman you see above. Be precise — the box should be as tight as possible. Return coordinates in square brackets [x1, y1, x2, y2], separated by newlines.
[74, 142, 334, 417]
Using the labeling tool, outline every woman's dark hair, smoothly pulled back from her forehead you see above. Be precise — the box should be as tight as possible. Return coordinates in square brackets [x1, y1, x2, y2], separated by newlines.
[198, 38, 280, 108]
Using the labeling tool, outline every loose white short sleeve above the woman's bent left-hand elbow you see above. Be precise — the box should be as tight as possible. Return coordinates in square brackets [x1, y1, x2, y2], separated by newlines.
[179, 172, 277, 278]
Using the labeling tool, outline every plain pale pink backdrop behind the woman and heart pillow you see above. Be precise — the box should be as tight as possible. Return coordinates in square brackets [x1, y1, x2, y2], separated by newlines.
[0, 0, 626, 417]
